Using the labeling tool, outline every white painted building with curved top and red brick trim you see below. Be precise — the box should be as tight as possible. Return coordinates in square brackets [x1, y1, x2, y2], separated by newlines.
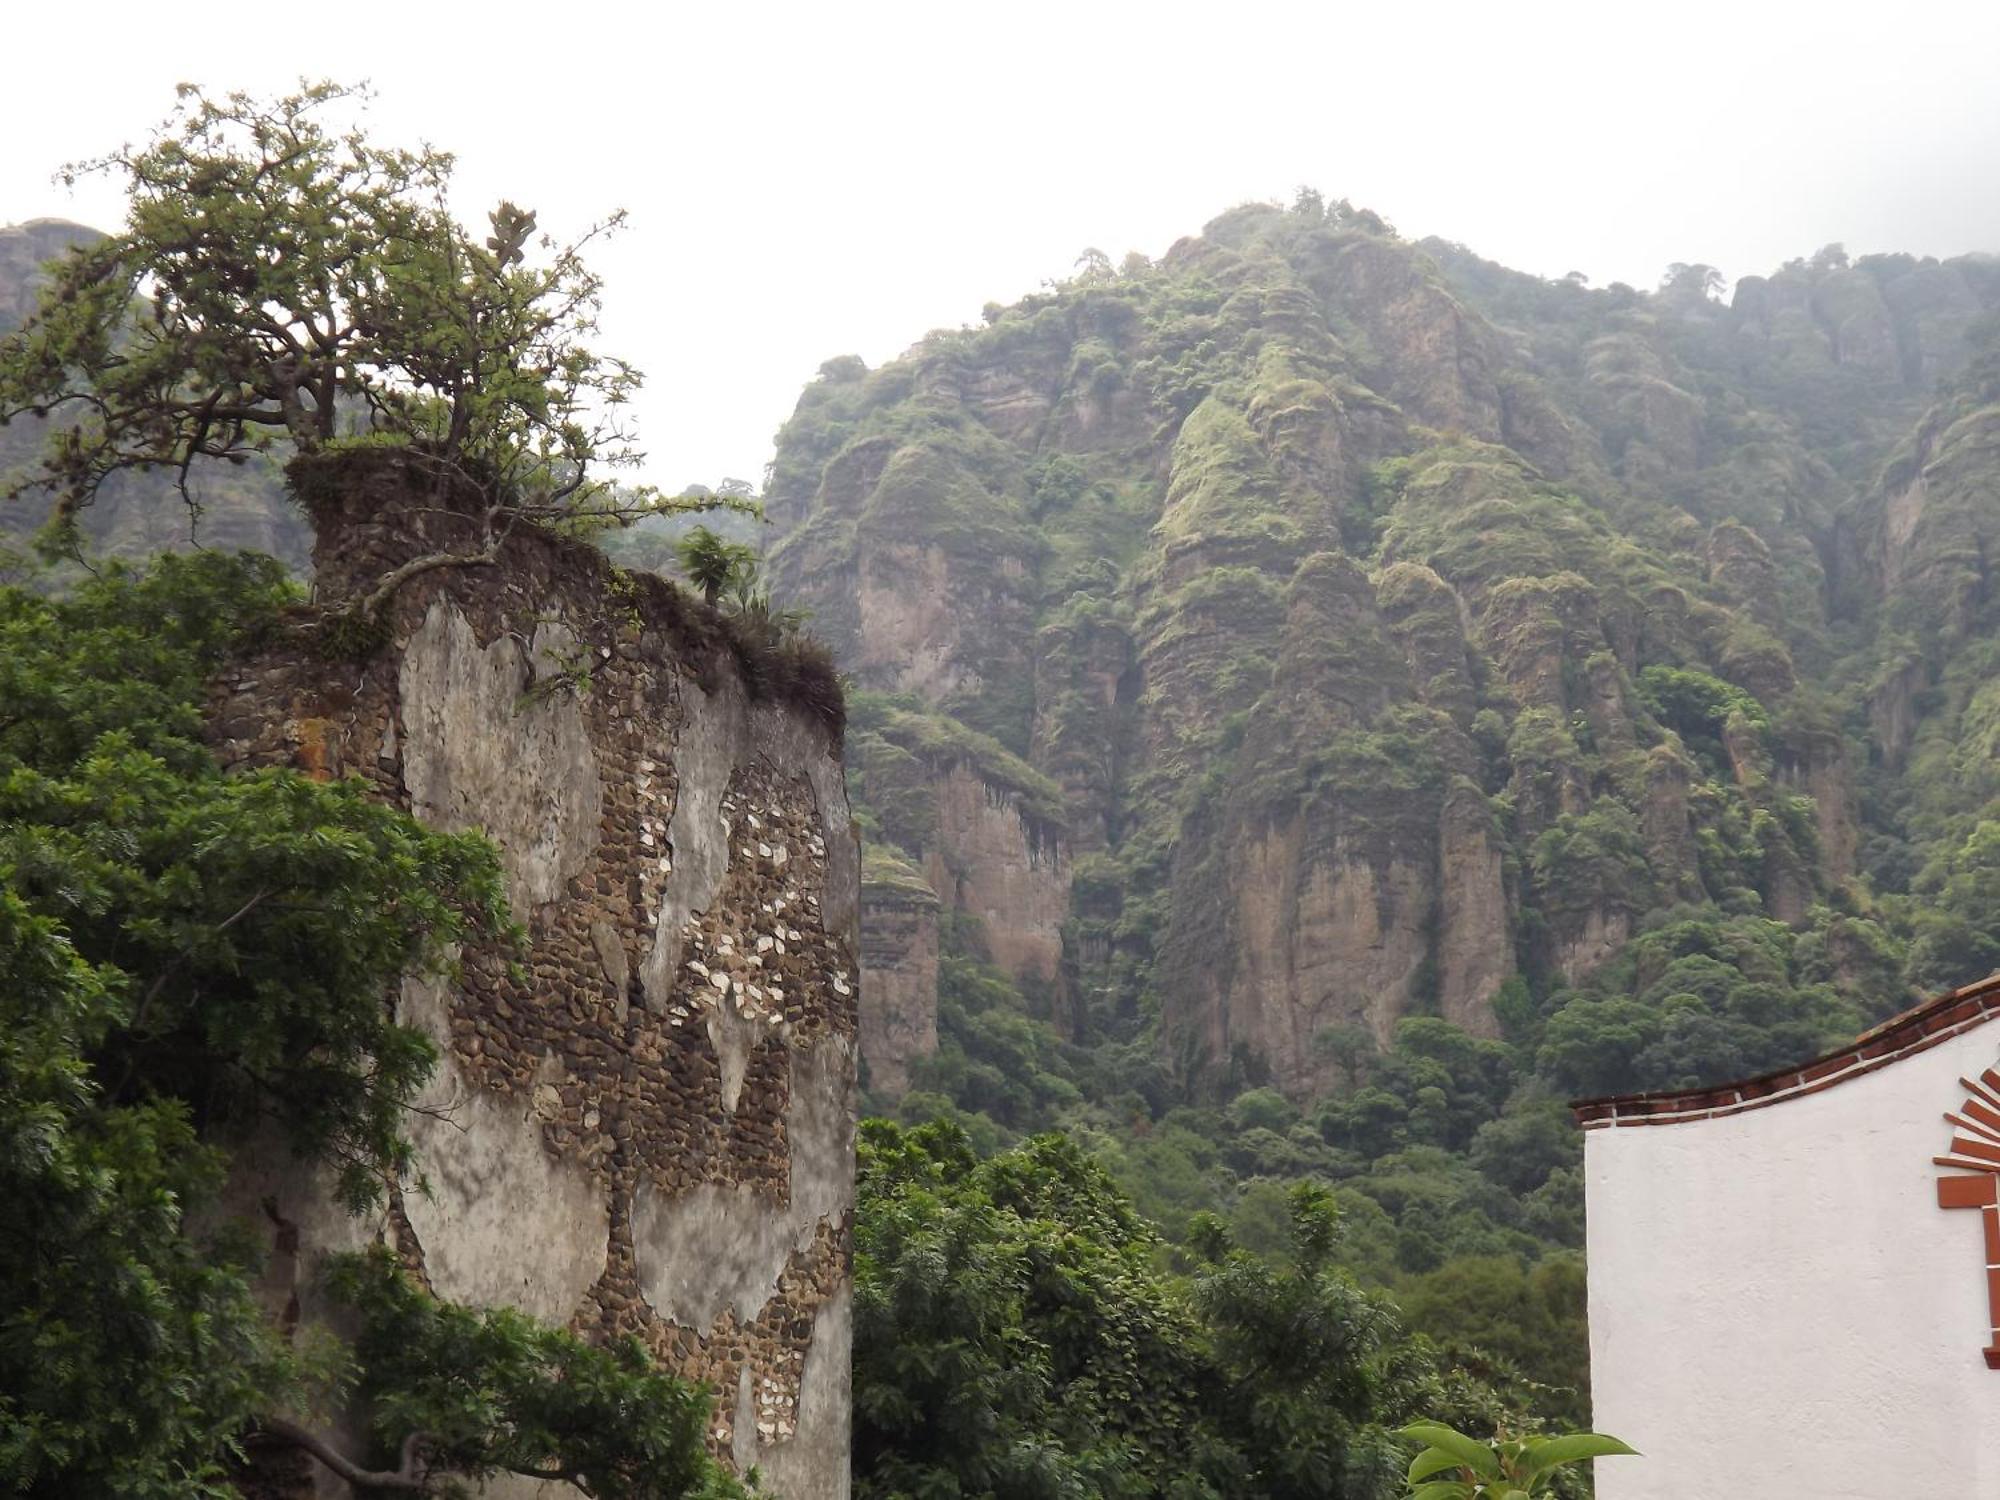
[1576, 976, 2000, 1500]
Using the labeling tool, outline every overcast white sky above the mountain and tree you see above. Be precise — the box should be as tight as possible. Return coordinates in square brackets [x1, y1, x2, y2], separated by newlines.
[0, 0, 2000, 484]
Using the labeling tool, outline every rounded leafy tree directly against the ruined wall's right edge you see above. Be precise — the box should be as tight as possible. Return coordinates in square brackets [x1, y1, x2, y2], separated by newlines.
[854, 1120, 1218, 1500]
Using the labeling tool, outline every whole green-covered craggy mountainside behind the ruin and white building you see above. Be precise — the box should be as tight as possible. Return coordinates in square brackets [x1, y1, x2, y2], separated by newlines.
[766, 192, 2000, 1424]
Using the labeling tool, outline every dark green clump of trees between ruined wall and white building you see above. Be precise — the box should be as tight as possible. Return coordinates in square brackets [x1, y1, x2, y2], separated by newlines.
[854, 1122, 1528, 1500]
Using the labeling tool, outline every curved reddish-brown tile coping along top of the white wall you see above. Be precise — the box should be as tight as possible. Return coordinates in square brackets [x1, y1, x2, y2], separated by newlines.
[1570, 974, 2000, 1130]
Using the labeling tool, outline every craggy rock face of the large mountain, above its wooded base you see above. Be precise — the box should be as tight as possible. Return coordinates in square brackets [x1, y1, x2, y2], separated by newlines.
[770, 204, 2000, 1094]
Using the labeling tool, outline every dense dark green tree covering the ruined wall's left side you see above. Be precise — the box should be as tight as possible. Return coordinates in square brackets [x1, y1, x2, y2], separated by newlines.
[0, 554, 748, 1500]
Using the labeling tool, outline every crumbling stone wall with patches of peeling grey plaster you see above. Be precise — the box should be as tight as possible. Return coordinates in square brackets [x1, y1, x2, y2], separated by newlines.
[212, 462, 858, 1500]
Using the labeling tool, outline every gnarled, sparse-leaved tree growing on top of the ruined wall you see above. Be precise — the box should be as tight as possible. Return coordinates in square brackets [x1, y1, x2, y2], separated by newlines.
[0, 84, 696, 588]
